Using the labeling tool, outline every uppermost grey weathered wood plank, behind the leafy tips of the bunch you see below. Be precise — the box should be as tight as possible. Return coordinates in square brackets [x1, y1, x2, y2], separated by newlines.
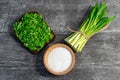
[0, 0, 120, 33]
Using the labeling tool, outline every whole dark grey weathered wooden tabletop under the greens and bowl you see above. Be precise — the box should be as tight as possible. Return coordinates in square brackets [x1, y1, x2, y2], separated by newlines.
[0, 0, 120, 80]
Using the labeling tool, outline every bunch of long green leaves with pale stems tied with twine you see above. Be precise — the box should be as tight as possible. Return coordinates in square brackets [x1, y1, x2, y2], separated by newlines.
[65, 3, 115, 52]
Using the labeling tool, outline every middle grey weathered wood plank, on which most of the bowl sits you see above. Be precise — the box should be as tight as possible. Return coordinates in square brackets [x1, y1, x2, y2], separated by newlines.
[0, 32, 120, 69]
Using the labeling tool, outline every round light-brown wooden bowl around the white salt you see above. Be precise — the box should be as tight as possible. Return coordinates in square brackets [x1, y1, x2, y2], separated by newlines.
[43, 43, 75, 75]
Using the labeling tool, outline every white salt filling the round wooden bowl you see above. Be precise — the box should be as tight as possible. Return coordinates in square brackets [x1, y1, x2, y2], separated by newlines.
[48, 47, 72, 72]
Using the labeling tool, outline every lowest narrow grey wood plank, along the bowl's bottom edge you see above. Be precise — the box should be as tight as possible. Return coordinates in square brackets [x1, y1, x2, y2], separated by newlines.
[0, 68, 120, 80]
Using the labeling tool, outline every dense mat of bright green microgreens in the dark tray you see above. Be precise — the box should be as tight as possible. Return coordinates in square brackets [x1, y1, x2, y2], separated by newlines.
[13, 13, 54, 51]
